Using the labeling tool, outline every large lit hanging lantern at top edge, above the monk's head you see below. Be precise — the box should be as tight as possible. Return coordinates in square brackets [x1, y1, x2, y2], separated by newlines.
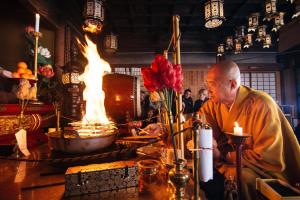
[205, 0, 225, 28]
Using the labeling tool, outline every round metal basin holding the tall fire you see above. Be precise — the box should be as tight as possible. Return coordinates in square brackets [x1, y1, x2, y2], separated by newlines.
[48, 131, 116, 154]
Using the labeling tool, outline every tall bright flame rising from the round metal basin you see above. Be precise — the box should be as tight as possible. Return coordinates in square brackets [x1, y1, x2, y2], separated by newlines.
[77, 36, 111, 124]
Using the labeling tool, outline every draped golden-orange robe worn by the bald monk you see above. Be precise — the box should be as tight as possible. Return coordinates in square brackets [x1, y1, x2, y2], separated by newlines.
[200, 86, 300, 184]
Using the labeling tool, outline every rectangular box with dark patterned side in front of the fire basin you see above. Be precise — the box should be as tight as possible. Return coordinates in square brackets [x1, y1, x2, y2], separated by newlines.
[65, 161, 138, 196]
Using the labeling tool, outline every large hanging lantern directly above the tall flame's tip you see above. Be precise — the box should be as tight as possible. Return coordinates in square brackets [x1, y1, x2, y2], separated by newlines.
[83, 0, 104, 33]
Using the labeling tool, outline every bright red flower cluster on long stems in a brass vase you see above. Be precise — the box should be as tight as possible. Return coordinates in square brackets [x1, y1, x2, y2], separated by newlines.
[141, 55, 183, 162]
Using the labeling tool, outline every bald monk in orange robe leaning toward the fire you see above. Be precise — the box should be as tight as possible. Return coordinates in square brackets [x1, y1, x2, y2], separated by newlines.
[195, 60, 300, 200]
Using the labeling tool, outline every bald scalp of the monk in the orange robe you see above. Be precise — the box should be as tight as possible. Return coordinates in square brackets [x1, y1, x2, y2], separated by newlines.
[208, 60, 241, 86]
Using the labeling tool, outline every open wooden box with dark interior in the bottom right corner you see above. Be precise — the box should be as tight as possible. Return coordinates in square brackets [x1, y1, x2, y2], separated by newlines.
[256, 178, 300, 200]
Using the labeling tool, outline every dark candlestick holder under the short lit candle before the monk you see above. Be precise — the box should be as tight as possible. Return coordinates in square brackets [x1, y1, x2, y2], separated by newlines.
[226, 132, 251, 200]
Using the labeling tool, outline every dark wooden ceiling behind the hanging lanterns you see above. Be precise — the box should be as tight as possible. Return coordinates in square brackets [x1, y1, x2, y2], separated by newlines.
[59, 0, 294, 52]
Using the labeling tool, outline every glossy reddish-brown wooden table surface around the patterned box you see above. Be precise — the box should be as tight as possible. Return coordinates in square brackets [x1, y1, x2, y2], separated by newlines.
[0, 144, 203, 200]
